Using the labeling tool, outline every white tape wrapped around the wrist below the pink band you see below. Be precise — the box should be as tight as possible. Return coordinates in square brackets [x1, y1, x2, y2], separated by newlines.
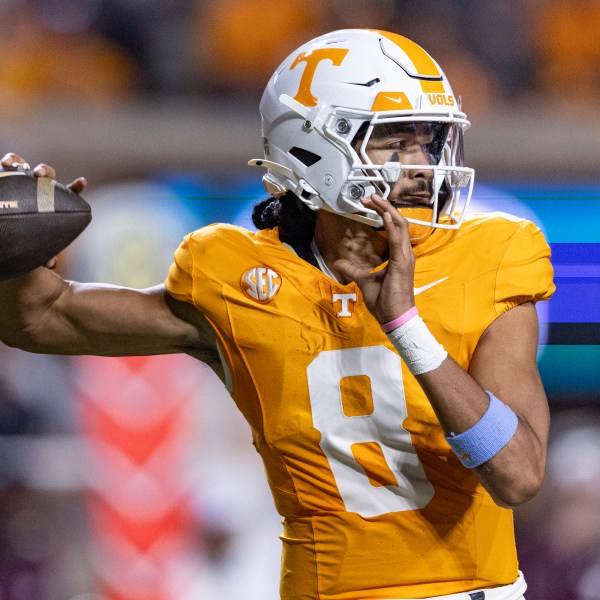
[387, 316, 448, 375]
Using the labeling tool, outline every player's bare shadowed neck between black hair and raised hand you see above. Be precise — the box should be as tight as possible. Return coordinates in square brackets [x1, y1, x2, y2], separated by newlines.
[314, 210, 388, 283]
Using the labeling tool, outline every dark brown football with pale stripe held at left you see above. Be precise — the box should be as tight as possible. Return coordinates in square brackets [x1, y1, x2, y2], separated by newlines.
[0, 171, 92, 279]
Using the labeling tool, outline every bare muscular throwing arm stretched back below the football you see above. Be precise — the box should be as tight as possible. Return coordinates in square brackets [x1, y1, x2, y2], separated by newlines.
[0, 268, 169, 356]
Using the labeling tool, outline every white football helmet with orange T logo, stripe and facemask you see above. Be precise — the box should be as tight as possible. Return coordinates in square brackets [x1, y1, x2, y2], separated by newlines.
[249, 29, 474, 237]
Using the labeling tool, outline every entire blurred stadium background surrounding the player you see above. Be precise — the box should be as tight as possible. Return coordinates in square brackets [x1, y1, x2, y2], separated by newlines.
[0, 0, 600, 600]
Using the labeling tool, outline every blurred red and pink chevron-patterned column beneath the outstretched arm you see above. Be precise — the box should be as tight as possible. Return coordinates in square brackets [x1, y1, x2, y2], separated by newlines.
[74, 355, 200, 600]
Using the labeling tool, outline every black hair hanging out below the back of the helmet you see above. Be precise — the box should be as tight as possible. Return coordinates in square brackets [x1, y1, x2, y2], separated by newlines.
[252, 192, 317, 266]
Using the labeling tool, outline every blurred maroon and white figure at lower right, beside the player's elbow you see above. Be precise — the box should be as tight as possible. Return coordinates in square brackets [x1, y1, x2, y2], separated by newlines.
[515, 406, 600, 600]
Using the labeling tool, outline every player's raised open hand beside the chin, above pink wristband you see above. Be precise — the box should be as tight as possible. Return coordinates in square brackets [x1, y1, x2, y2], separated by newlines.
[334, 194, 415, 324]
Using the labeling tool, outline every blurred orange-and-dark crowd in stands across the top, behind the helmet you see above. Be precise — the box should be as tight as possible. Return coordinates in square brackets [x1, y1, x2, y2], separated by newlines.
[0, 0, 600, 113]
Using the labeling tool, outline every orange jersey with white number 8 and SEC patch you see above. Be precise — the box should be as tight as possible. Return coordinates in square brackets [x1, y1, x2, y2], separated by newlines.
[166, 214, 554, 600]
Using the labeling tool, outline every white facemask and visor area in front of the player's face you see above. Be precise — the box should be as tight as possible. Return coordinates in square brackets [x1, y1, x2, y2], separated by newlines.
[324, 111, 473, 240]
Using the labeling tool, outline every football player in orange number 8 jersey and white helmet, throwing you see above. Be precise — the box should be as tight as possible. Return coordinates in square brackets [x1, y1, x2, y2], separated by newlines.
[0, 30, 554, 600]
